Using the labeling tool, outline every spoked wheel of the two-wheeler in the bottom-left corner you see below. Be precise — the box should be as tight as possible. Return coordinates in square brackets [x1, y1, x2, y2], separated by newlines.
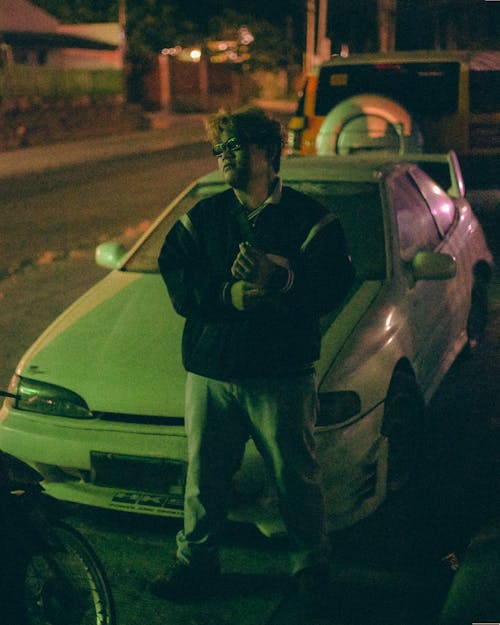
[23, 522, 115, 625]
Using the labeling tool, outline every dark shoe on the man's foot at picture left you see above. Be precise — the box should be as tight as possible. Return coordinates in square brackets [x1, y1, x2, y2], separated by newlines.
[151, 560, 221, 601]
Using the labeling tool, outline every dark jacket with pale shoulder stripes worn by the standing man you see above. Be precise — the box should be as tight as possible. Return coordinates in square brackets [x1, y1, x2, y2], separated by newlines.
[158, 187, 354, 380]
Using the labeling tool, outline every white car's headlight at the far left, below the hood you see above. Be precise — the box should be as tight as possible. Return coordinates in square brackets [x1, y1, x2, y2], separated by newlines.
[15, 377, 94, 419]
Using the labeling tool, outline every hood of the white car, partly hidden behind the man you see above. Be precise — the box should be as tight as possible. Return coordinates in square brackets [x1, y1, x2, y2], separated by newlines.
[17, 271, 380, 416]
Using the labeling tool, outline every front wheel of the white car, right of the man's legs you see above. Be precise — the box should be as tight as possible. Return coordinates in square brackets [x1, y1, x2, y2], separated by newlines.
[382, 370, 425, 492]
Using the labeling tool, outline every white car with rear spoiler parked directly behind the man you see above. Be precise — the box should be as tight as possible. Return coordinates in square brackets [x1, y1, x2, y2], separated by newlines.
[0, 153, 492, 535]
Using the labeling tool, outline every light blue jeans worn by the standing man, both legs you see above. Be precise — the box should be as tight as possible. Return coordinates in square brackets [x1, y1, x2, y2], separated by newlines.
[177, 373, 328, 573]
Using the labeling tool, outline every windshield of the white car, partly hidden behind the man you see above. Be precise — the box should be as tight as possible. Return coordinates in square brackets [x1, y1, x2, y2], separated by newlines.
[124, 179, 385, 280]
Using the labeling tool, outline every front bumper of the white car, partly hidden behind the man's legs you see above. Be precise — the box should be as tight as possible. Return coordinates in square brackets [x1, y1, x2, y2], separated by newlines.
[0, 402, 387, 536]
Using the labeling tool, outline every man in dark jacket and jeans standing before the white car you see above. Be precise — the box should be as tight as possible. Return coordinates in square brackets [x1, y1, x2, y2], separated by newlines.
[152, 107, 354, 599]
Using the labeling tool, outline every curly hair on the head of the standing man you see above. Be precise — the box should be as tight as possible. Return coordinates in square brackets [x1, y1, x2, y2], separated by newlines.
[206, 106, 283, 172]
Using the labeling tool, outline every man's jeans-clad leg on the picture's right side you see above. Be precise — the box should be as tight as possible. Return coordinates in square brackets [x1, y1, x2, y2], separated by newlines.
[241, 375, 329, 573]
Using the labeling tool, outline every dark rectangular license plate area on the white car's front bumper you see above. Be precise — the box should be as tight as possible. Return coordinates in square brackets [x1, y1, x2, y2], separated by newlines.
[90, 451, 186, 498]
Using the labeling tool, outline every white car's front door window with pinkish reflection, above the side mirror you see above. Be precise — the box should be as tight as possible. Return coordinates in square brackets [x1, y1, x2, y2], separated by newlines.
[388, 174, 440, 261]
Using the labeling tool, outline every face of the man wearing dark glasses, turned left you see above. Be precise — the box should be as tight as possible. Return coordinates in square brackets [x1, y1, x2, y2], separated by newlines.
[218, 130, 270, 191]
